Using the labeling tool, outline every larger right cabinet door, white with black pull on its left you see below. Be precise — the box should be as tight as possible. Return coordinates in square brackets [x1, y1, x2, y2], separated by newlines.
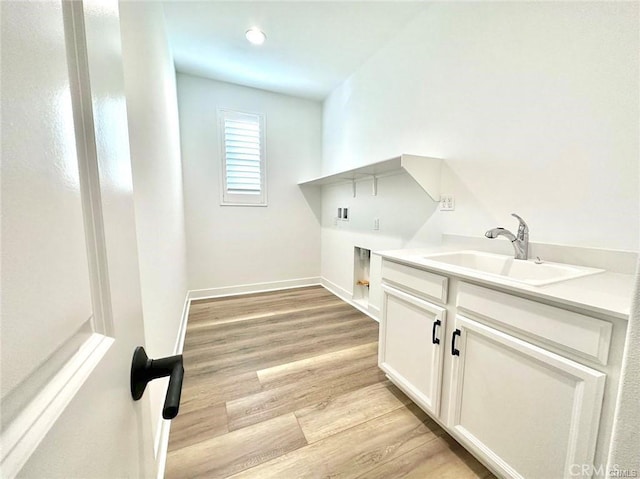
[449, 316, 605, 479]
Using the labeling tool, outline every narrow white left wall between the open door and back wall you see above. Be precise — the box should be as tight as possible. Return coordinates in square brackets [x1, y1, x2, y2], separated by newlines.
[120, 2, 187, 442]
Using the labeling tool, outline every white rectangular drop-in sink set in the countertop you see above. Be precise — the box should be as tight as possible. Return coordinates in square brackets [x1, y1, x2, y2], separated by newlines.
[423, 251, 604, 286]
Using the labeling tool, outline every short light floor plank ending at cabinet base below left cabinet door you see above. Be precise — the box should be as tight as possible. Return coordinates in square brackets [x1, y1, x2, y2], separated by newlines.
[295, 381, 410, 444]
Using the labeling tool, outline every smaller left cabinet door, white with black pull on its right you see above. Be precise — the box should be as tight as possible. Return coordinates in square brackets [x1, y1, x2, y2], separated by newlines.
[378, 285, 446, 416]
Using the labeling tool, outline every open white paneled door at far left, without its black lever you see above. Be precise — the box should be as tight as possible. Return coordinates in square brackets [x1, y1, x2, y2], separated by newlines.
[0, 0, 155, 478]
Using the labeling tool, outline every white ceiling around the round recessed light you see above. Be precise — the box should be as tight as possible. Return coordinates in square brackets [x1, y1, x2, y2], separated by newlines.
[164, 1, 426, 100]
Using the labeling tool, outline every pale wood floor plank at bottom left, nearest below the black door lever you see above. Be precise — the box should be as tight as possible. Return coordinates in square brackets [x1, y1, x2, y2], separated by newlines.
[165, 414, 306, 479]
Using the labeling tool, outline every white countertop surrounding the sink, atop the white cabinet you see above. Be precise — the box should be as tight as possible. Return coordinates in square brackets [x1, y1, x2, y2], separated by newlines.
[374, 248, 634, 320]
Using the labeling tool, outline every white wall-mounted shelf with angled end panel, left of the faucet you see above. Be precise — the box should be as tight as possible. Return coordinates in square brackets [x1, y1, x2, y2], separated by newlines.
[298, 155, 442, 201]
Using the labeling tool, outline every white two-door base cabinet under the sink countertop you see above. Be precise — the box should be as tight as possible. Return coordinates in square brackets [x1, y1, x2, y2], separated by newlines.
[379, 259, 622, 479]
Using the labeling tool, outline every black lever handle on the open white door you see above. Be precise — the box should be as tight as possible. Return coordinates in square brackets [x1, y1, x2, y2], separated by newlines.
[131, 346, 184, 419]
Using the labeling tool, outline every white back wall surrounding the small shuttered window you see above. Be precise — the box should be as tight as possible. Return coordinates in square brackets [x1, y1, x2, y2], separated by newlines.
[178, 73, 322, 289]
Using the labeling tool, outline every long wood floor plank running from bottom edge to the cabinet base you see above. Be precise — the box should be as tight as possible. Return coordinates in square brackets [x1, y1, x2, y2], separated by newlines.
[232, 405, 439, 479]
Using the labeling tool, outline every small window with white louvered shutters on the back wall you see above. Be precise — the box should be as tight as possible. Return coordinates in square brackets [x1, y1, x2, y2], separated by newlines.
[218, 110, 267, 206]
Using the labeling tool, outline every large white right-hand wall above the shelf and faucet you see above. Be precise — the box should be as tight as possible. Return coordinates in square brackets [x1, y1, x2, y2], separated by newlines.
[323, 2, 640, 253]
